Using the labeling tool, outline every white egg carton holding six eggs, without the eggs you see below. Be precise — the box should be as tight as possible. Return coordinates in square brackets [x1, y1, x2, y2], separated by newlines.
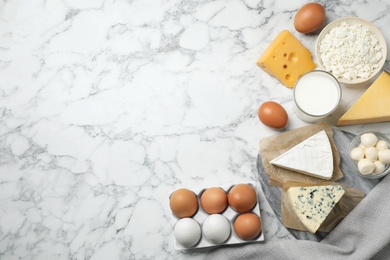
[171, 182, 264, 250]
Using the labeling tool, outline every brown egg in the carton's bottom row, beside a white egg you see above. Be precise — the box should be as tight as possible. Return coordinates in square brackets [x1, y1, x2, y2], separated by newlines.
[234, 212, 262, 240]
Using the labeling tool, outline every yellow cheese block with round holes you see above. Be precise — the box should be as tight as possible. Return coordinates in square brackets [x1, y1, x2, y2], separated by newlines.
[256, 30, 317, 88]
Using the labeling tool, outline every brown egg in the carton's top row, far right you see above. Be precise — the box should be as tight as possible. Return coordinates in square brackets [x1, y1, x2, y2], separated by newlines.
[228, 184, 257, 213]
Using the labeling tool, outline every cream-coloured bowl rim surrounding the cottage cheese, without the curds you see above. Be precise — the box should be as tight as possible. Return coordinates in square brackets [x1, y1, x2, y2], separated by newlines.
[315, 17, 387, 85]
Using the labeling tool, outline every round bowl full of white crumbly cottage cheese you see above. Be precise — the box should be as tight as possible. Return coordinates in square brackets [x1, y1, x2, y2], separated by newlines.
[315, 17, 387, 85]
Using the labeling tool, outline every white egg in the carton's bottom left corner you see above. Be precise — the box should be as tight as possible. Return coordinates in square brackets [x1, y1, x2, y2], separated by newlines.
[173, 218, 202, 247]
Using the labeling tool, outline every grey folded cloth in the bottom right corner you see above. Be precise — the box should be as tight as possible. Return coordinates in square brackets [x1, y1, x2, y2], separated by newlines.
[206, 172, 390, 260]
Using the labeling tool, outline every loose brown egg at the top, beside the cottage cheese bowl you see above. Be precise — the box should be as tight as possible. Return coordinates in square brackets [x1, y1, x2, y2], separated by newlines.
[294, 3, 326, 33]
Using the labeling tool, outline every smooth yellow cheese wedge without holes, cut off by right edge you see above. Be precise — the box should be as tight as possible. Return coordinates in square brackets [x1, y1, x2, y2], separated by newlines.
[337, 71, 390, 126]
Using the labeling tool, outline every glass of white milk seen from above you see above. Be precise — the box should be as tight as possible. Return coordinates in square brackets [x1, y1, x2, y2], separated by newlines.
[293, 70, 341, 123]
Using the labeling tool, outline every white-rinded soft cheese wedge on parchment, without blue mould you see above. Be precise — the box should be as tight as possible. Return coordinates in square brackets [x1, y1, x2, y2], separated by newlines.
[271, 130, 333, 180]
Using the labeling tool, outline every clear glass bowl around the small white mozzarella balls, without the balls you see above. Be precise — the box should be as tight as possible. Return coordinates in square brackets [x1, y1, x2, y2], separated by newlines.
[347, 131, 390, 179]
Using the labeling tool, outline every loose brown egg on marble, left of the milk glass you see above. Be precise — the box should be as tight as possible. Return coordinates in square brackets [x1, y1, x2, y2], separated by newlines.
[258, 101, 288, 128]
